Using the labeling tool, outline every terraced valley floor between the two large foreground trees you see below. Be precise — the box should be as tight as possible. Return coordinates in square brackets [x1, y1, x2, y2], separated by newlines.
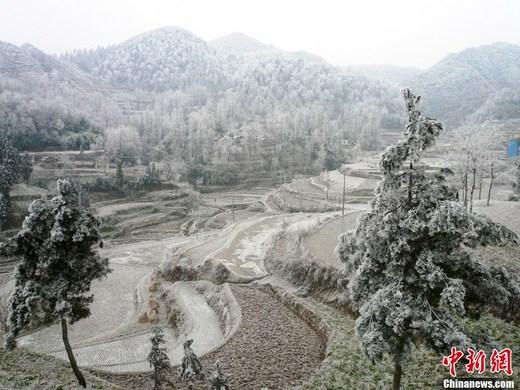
[3, 152, 520, 389]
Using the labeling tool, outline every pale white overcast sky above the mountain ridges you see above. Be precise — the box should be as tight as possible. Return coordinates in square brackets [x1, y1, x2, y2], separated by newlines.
[0, 0, 520, 68]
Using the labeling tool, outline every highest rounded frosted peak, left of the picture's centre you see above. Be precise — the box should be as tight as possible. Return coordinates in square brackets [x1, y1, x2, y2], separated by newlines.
[65, 27, 223, 92]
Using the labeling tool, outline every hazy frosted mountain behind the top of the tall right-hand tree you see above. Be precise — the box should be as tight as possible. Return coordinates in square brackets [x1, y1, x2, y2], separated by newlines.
[410, 43, 520, 125]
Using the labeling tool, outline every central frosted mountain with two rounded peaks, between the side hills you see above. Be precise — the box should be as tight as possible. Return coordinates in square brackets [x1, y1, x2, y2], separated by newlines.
[64, 27, 395, 122]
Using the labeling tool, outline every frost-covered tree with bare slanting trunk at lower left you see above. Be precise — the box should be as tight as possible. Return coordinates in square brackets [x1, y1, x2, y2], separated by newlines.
[0, 180, 110, 387]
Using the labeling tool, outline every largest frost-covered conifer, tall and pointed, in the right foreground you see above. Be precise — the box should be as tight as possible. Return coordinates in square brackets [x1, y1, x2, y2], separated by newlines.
[337, 89, 520, 389]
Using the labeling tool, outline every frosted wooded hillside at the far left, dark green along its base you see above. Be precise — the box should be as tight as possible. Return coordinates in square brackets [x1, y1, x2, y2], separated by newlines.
[0, 42, 124, 150]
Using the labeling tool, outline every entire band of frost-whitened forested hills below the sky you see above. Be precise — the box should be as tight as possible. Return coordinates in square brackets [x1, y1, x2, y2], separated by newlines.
[0, 28, 520, 178]
